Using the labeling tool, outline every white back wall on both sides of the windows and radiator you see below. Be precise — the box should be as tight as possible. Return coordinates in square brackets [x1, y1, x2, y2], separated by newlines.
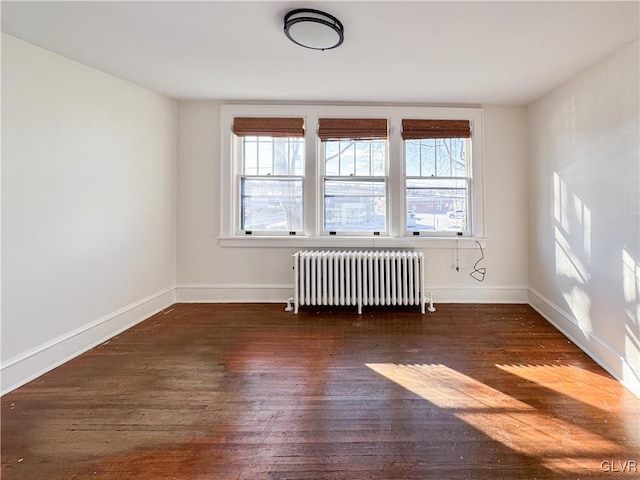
[177, 101, 528, 302]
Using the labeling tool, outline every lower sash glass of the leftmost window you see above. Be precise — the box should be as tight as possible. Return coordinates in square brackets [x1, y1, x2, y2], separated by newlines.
[240, 178, 302, 231]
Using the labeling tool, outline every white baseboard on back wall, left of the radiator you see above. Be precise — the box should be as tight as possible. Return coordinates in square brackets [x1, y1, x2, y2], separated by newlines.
[176, 283, 293, 303]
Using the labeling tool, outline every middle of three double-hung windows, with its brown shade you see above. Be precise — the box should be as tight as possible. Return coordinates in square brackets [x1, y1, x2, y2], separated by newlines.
[318, 118, 389, 235]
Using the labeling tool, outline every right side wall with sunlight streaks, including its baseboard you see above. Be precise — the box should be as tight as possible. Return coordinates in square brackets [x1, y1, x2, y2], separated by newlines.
[529, 41, 640, 394]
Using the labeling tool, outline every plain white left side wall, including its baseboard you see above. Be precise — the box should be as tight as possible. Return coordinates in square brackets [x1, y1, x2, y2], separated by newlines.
[2, 34, 177, 391]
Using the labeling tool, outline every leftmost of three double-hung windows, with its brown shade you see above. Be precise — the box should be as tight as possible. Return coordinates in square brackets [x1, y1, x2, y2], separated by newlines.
[233, 117, 305, 235]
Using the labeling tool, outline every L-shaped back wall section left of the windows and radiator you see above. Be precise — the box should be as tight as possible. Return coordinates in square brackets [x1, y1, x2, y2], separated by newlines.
[177, 101, 293, 302]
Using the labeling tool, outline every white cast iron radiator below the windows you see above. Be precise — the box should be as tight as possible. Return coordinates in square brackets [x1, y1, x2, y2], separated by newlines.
[293, 250, 426, 314]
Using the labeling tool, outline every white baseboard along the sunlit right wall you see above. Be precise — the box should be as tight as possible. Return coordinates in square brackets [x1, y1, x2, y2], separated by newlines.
[529, 288, 640, 397]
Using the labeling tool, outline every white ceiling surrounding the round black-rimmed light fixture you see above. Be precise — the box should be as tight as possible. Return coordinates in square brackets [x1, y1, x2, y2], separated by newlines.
[2, 1, 640, 104]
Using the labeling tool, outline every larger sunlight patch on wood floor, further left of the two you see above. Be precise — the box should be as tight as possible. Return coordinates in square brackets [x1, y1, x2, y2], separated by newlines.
[366, 363, 621, 471]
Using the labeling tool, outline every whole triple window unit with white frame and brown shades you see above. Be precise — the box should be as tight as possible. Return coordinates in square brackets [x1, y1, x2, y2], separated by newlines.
[219, 104, 484, 248]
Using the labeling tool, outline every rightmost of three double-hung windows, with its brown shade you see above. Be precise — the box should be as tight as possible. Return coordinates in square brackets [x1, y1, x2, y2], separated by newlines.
[402, 119, 472, 235]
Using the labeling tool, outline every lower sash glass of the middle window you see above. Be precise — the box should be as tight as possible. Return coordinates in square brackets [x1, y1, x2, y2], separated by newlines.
[324, 179, 386, 232]
